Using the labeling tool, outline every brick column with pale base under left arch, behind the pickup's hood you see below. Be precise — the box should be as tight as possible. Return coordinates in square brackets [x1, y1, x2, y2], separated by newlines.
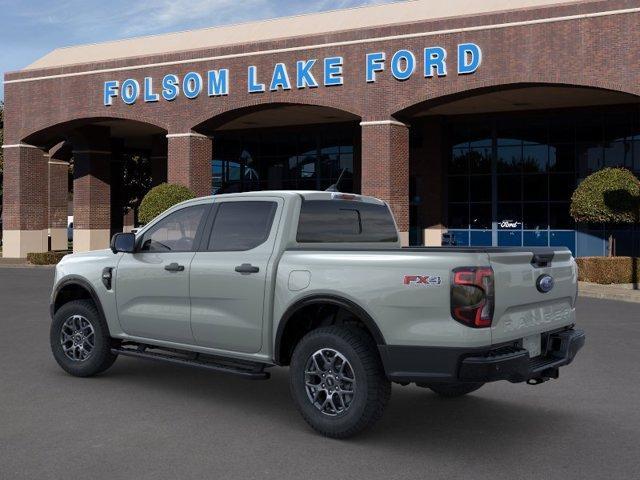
[73, 127, 111, 252]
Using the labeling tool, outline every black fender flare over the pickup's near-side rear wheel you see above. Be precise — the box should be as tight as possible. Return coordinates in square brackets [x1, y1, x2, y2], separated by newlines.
[273, 294, 386, 365]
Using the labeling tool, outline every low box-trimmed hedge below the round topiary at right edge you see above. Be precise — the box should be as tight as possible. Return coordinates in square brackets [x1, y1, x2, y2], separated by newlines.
[576, 257, 640, 284]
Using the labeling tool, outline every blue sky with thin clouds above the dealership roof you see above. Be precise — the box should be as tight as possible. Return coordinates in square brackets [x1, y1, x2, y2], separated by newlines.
[0, 0, 400, 100]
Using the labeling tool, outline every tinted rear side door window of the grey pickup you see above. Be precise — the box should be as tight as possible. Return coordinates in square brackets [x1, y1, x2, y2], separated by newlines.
[207, 201, 278, 252]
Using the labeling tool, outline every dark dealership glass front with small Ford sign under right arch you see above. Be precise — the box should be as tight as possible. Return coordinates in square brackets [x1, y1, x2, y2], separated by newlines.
[447, 107, 640, 255]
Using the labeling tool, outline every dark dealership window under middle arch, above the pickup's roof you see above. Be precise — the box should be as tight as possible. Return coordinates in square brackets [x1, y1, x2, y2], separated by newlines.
[211, 123, 359, 194]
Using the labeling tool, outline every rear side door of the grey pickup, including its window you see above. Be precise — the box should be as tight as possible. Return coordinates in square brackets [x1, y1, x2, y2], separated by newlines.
[191, 197, 283, 353]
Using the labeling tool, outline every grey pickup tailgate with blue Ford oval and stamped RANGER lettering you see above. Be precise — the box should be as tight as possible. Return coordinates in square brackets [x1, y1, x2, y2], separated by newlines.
[487, 247, 577, 348]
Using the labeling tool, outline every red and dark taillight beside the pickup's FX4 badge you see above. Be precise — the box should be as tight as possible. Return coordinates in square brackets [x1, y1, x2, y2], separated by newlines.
[451, 267, 495, 328]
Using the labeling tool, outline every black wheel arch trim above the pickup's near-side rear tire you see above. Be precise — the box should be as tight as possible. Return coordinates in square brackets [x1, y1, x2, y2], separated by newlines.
[274, 294, 386, 365]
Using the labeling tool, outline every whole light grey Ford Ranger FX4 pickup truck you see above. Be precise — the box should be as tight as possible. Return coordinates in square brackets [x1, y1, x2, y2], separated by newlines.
[50, 191, 585, 438]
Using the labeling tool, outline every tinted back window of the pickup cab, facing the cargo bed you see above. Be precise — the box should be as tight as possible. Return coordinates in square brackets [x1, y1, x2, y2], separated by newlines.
[296, 200, 398, 243]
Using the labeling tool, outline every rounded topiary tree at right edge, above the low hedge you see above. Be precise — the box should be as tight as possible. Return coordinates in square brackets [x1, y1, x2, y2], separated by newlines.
[570, 168, 640, 256]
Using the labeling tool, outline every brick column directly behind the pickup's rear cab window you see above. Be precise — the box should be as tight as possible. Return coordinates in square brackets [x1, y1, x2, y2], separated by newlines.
[360, 120, 409, 245]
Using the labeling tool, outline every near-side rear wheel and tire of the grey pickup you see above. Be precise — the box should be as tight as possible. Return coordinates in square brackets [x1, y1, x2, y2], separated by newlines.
[289, 326, 391, 438]
